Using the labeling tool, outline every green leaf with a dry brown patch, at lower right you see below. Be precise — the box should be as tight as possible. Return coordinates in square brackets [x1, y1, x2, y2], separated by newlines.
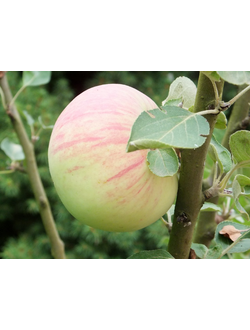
[214, 221, 250, 255]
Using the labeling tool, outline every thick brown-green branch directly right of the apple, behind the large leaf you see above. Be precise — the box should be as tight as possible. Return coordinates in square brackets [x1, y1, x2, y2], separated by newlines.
[168, 73, 224, 259]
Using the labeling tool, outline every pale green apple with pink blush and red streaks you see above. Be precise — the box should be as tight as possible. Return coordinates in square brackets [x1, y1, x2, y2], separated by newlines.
[48, 84, 178, 232]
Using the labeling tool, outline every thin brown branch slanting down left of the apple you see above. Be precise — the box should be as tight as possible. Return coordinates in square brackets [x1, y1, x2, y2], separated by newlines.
[0, 74, 66, 259]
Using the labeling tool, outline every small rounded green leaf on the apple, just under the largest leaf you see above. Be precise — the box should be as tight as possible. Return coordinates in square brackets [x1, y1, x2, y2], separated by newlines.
[147, 148, 179, 177]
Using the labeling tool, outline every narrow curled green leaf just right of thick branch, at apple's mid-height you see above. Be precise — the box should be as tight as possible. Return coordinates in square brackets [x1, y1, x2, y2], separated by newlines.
[209, 135, 233, 174]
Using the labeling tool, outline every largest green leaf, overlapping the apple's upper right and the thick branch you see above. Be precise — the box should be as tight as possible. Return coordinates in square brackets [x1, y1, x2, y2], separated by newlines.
[127, 107, 210, 152]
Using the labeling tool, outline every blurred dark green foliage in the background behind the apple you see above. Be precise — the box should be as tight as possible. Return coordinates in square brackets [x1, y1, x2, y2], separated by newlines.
[0, 71, 236, 259]
